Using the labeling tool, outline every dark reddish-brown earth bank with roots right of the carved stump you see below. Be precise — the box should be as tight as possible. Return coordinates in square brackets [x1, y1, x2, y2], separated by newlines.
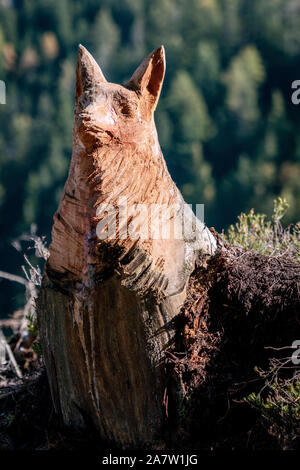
[166, 239, 300, 449]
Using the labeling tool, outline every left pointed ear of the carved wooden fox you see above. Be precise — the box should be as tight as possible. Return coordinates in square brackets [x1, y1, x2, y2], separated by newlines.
[76, 44, 106, 103]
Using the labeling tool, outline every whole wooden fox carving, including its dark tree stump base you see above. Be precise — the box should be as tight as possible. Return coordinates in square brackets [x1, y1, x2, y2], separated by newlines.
[39, 46, 216, 446]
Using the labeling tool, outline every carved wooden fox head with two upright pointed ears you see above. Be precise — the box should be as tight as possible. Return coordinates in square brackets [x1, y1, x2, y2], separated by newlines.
[75, 45, 165, 148]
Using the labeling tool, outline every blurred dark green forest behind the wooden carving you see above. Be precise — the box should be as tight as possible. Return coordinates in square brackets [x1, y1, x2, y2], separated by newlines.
[0, 0, 300, 317]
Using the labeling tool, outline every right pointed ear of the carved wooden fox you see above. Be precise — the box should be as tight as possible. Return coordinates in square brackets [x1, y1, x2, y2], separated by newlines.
[125, 46, 166, 112]
